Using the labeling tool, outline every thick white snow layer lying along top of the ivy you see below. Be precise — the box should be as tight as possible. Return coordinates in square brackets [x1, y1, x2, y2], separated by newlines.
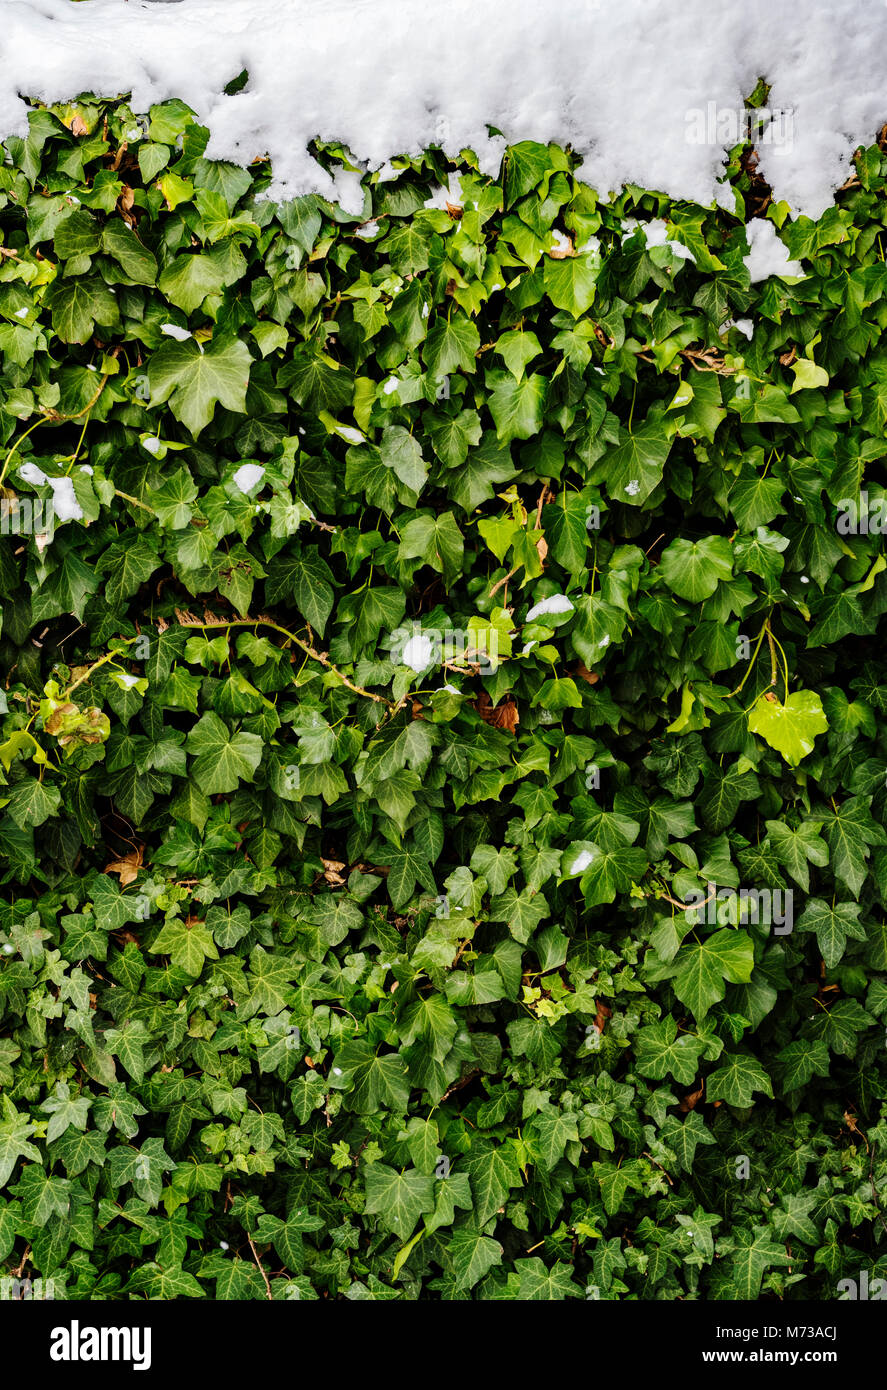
[0, 0, 887, 217]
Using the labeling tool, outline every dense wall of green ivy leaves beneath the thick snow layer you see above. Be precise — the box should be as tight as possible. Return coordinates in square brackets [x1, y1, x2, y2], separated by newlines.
[0, 99, 887, 1300]
